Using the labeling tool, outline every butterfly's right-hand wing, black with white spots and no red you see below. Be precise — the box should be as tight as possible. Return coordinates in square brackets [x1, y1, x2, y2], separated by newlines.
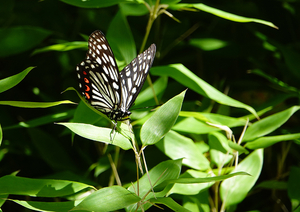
[120, 44, 156, 110]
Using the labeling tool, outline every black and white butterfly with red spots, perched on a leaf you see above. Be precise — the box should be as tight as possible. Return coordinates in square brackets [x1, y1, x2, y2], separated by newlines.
[76, 30, 156, 122]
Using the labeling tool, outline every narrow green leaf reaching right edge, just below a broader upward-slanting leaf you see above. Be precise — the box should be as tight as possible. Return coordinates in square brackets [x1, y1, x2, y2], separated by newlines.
[245, 133, 300, 149]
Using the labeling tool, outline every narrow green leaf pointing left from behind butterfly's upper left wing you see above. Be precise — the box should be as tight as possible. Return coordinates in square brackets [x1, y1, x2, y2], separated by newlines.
[32, 41, 88, 55]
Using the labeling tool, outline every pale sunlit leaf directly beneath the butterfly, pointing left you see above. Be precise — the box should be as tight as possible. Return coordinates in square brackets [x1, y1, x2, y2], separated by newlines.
[57, 123, 132, 150]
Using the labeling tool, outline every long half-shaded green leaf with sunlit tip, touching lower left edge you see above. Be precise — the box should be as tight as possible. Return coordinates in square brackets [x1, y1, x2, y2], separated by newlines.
[0, 175, 94, 197]
